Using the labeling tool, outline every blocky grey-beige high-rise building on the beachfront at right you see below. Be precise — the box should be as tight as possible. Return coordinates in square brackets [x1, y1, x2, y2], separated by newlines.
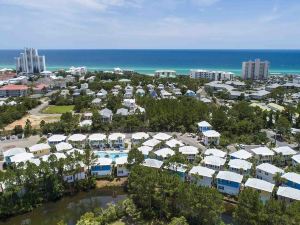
[242, 59, 269, 80]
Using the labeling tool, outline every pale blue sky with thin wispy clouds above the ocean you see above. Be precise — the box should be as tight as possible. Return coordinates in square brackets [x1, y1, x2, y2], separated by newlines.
[0, 0, 300, 49]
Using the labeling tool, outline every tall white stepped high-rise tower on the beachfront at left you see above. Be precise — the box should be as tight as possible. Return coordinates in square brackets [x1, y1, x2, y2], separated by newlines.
[16, 48, 46, 74]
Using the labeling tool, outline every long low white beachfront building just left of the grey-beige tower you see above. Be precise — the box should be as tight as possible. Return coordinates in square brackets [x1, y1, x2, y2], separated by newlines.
[190, 69, 234, 81]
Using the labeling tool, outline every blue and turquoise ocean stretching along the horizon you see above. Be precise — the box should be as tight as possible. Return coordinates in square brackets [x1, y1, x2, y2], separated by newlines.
[0, 49, 300, 75]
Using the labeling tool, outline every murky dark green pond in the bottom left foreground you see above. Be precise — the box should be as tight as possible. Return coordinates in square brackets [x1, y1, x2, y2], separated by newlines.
[0, 187, 126, 225]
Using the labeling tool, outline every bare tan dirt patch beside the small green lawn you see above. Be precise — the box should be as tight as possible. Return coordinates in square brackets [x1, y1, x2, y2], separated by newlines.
[5, 115, 60, 130]
